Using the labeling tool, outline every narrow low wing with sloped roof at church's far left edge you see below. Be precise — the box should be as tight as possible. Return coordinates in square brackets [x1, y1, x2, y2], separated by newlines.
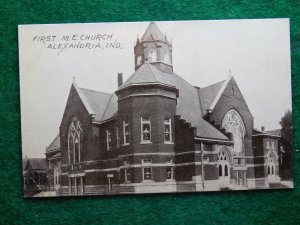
[45, 135, 61, 191]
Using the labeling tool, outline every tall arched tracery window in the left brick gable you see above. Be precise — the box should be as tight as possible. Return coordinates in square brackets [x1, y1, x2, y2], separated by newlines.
[68, 117, 83, 163]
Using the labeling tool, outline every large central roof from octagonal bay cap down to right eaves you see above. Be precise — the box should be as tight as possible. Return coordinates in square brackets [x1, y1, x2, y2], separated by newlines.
[119, 63, 228, 140]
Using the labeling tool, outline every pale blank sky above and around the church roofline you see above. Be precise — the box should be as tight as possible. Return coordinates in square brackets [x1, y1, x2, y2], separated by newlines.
[19, 19, 291, 157]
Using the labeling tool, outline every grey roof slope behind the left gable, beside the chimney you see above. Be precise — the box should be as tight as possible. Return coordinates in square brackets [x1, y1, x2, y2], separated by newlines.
[73, 82, 118, 122]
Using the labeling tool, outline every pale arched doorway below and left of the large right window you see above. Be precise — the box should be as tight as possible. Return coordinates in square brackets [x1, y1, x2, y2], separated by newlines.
[218, 149, 230, 187]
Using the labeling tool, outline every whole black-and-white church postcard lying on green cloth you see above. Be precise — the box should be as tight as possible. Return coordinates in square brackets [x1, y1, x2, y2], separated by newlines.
[18, 19, 294, 197]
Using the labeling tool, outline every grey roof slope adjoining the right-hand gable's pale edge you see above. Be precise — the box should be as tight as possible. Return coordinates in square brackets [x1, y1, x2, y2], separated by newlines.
[199, 80, 226, 115]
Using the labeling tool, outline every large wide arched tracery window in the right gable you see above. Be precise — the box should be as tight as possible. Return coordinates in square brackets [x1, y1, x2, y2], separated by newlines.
[222, 109, 245, 153]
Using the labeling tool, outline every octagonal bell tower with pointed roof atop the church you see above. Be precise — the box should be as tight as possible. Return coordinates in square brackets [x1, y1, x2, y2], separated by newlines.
[134, 22, 173, 73]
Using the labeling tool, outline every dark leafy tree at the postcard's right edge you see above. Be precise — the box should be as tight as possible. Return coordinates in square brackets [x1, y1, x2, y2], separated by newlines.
[279, 109, 293, 179]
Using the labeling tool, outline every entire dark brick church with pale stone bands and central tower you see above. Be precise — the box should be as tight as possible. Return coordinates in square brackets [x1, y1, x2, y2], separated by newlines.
[46, 22, 280, 195]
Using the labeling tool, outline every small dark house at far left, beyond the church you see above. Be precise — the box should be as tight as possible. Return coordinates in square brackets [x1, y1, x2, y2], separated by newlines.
[22, 158, 47, 196]
